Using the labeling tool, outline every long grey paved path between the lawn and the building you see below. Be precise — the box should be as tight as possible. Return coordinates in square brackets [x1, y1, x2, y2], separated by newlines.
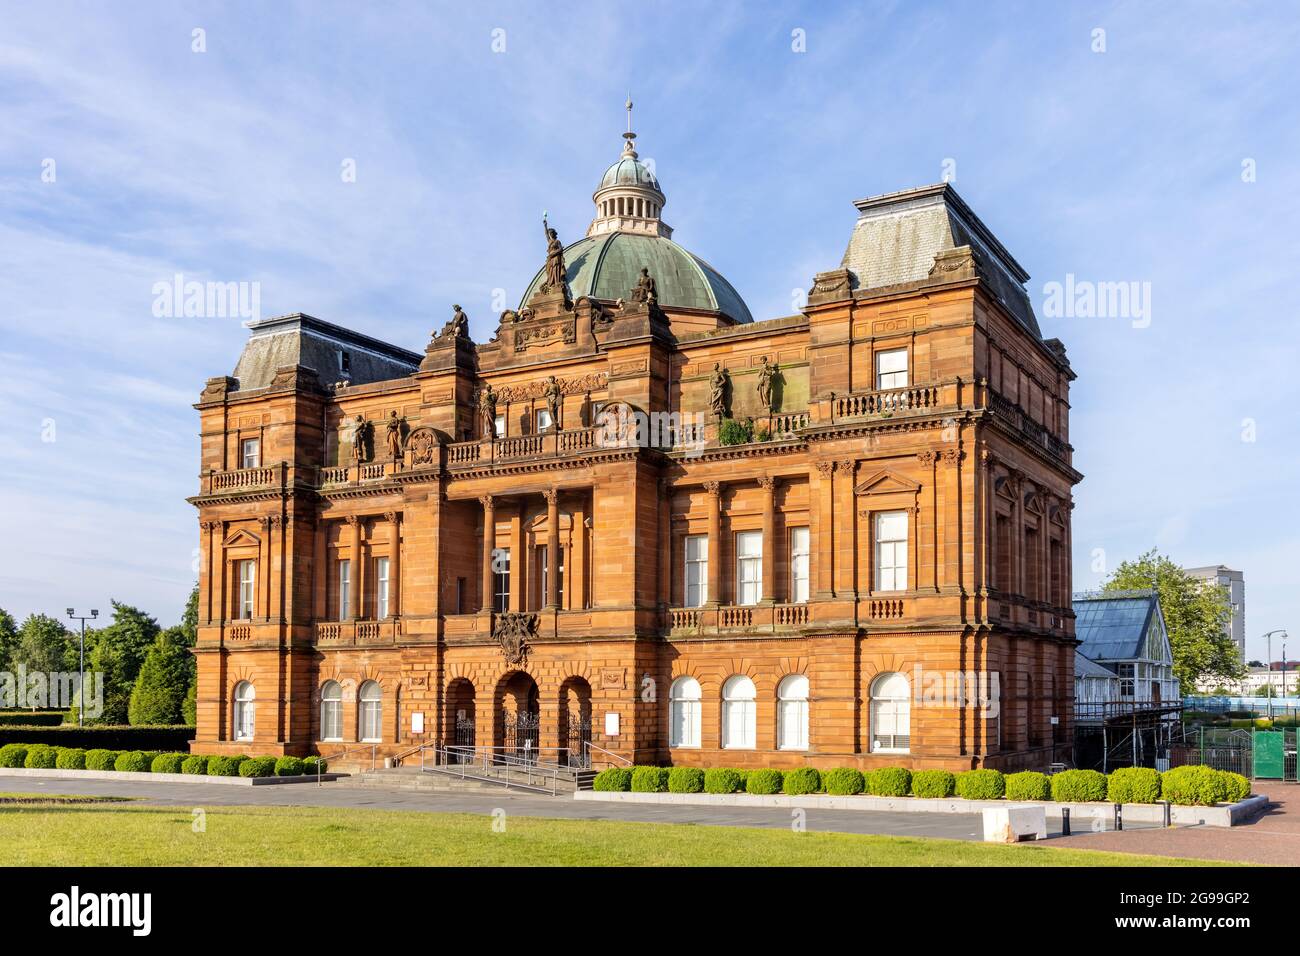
[0, 777, 983, 840]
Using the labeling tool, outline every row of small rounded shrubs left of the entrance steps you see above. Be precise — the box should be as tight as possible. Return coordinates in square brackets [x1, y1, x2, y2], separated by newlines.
[0, 744, 327, 777]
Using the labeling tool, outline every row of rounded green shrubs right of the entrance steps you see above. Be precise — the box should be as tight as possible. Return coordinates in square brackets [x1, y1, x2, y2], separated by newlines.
[587, 750, 1251, 806]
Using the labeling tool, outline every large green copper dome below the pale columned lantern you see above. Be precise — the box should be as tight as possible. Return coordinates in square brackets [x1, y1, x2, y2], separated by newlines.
[520, 232, 754, 323]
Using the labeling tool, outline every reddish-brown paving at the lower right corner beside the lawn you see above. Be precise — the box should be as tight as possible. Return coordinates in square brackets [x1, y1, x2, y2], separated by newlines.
[1052, 780, 1300, 866]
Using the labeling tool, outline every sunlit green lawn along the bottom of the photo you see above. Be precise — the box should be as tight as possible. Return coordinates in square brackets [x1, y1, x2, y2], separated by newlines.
[0, 805, 1227, 866]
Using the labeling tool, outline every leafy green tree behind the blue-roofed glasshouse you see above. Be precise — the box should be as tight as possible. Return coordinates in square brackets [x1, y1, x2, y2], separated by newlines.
[1101, 549, 1245, 688]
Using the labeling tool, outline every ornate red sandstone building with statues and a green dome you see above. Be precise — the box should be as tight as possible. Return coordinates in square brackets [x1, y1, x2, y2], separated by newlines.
[191, 123, 1082, 770]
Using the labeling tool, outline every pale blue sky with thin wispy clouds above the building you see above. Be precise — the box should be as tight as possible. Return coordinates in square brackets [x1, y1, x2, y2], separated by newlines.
[0, 3, 1300, 656]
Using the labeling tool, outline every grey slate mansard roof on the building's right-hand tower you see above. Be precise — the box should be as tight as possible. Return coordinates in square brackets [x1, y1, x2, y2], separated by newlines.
[841, 182, 1043, 339]
